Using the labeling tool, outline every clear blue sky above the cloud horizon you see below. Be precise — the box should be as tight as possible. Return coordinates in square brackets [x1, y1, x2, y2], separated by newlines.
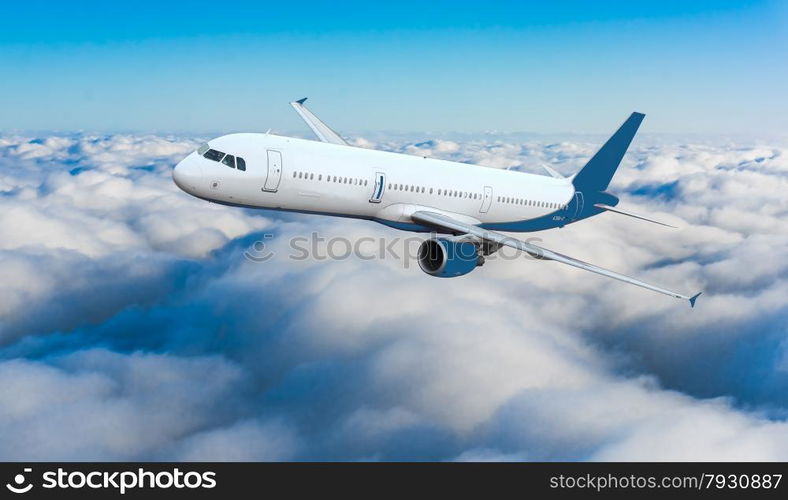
[0, 1, 788, 135]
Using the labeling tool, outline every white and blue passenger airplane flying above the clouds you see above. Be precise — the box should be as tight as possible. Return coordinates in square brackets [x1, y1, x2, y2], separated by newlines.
[172, 98, 700, 307]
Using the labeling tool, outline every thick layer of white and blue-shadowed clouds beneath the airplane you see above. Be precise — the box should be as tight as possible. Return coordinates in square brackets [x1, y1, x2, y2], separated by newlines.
[0, 135, 788, 460]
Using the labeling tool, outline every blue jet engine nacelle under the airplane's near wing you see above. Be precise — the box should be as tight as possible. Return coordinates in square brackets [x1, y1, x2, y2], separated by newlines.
[419, 238, 484, 278]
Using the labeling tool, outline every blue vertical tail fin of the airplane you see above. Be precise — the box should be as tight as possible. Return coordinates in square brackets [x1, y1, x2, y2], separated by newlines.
[572, 113, 646, 193]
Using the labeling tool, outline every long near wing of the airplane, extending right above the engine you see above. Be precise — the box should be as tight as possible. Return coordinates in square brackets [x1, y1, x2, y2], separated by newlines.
[410, 211, 700, 307]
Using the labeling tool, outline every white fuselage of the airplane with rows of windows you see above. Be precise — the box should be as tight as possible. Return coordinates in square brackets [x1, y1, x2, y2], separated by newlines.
[173, 133, 575, 231]
